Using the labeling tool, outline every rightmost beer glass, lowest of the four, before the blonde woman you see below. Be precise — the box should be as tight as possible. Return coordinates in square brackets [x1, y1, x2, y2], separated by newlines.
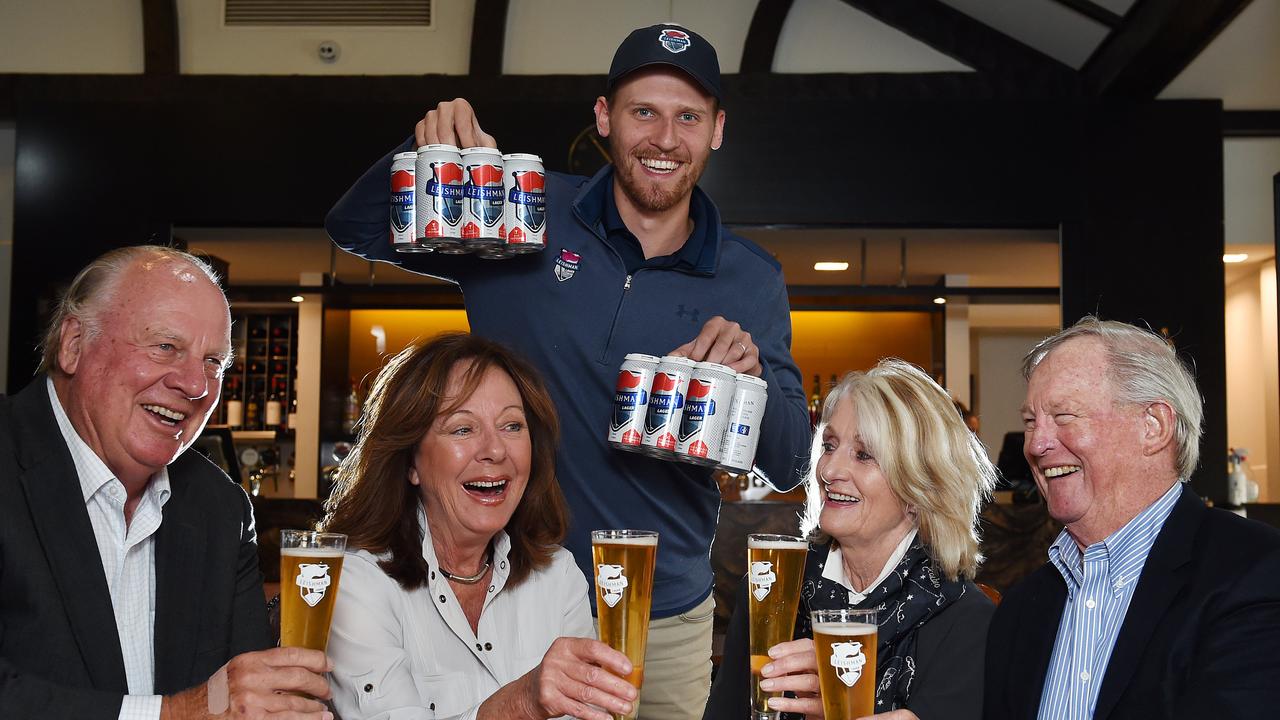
[810, 610, 877, 720]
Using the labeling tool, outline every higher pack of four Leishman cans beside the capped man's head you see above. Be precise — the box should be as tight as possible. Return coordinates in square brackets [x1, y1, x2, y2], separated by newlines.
[390, 145, 547, 260]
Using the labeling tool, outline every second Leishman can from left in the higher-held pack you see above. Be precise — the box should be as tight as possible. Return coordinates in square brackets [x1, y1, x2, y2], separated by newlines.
[413, 145, 463, 249]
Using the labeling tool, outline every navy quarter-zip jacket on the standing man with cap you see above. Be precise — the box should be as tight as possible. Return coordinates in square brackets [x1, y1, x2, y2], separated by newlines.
[325, 142, 810, 618]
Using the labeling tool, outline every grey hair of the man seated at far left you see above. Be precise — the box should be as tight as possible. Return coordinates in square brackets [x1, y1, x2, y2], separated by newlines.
[36, 245, 220, 374]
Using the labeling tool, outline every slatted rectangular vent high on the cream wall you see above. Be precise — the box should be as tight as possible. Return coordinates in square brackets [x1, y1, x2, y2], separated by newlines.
[223, 0, 431, 27]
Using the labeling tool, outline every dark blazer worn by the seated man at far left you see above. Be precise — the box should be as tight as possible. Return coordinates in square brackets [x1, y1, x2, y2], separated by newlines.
[0, 375, 269, 720]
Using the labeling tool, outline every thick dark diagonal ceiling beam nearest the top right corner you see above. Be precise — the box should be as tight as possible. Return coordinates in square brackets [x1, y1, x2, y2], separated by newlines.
[1080, 0, 1251, 100]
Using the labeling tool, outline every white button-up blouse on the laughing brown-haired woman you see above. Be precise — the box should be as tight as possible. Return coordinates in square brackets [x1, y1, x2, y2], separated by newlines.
[328, 515, 595, 720]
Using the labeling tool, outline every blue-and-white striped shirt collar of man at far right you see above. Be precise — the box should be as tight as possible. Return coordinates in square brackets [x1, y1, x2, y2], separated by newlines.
[1048, 482, 1183, 594]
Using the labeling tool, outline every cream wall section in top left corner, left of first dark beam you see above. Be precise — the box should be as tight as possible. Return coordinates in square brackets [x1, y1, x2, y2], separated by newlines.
[0, 0, 144, 73]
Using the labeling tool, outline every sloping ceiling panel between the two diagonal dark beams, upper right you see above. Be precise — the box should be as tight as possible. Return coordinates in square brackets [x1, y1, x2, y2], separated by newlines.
[942, 0, 1107, 69]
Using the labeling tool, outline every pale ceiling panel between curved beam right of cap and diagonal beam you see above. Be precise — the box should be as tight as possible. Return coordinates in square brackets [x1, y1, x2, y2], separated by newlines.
[773, 0, 970, 73]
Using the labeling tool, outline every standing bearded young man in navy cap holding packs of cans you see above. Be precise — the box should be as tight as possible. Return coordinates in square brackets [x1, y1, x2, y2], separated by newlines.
[325, 26, 810, 719]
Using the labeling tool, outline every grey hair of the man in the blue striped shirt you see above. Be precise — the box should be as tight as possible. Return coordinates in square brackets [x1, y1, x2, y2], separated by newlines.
[1023, 315, 1204, 480]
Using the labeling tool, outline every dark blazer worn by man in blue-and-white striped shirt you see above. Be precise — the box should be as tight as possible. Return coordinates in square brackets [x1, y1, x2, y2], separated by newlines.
[984, 488, 1280, 720]
